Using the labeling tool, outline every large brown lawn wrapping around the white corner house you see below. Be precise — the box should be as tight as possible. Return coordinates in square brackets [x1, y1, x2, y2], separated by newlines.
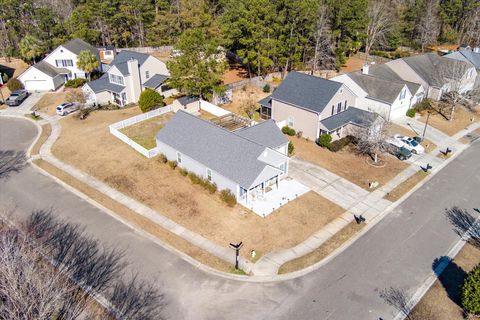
[53, 108, 344, 257]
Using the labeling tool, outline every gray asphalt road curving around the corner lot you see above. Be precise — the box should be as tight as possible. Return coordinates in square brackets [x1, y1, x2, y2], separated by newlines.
[0, 118, 480, 320]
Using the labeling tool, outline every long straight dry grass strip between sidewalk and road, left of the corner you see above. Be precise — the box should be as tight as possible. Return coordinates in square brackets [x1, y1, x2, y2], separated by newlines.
[33, 160, 235, 272]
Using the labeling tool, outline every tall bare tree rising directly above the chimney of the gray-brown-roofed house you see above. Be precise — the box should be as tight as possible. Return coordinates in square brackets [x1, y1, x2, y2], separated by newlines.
[365, 0, 393, 62]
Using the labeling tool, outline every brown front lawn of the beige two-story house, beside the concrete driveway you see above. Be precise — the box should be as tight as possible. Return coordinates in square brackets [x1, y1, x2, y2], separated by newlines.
[289, 137, 408, 191]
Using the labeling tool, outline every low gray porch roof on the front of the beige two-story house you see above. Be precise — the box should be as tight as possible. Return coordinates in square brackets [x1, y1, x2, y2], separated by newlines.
[320, 107, 378, 131]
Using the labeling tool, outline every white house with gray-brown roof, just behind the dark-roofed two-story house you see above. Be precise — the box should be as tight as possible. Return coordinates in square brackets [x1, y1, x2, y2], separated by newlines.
[332, 65, 412, 121]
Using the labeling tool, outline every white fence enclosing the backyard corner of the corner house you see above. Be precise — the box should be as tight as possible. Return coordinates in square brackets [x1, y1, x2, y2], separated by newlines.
[109, 105, 172, 158]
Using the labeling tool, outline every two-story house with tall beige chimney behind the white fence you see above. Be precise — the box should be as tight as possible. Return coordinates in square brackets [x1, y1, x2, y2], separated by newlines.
[83, 50, 176, 106]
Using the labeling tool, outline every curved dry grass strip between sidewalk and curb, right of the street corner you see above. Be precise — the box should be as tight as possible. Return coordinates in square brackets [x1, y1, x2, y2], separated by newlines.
[278, 222, 365, 274]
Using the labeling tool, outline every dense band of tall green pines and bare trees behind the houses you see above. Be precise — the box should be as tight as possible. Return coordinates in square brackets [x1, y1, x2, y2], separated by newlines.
[0, 0, 480, 74]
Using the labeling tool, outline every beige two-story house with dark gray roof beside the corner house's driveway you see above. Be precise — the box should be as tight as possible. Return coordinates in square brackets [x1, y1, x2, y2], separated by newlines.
[259, 71, 373, 140]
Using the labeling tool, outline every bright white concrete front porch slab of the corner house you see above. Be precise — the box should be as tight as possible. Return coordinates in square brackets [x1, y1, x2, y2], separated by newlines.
[239, 177, 310, 218]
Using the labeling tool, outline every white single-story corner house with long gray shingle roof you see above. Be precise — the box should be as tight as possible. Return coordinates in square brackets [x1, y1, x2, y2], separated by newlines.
[156, 110, 288, 205]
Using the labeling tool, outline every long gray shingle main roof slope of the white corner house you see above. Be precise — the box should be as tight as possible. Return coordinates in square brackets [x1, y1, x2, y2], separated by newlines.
[156, 110, 284, 188]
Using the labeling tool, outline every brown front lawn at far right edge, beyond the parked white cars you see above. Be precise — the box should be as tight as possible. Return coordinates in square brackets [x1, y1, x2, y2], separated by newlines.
[419, 106, 480, 136]
